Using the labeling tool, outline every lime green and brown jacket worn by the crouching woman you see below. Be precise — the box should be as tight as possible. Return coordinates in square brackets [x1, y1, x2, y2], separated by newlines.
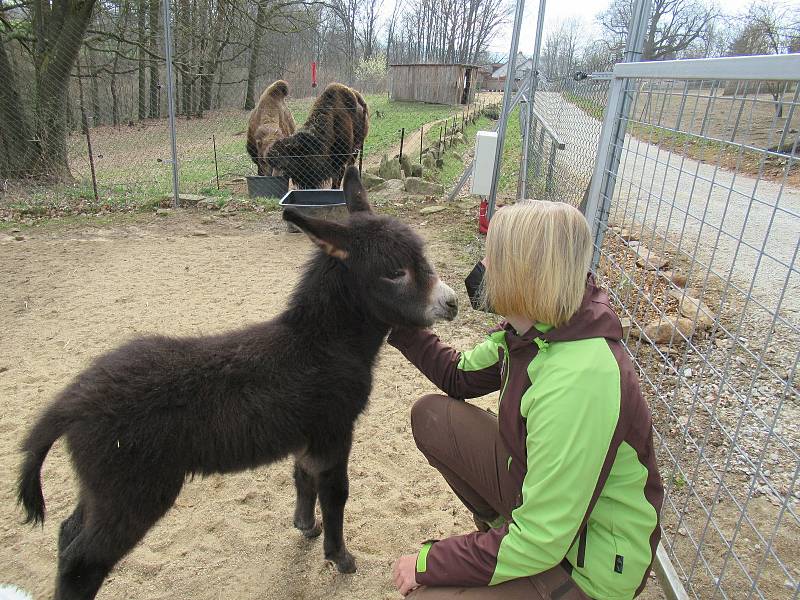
[388, 277, 663, 600]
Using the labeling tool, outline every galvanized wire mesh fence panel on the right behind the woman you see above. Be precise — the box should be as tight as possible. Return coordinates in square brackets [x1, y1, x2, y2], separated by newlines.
[587, 55, 800, 600]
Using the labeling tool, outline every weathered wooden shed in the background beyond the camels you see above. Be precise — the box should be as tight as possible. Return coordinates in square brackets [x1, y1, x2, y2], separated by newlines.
[389, 64, 480, 104]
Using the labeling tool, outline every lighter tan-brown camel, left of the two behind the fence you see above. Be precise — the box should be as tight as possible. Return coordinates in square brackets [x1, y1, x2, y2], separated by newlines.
[247, 81, 297, 175]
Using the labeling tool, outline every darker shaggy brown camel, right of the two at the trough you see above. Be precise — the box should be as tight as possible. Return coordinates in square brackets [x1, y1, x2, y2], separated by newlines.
[267, 83, 369, 189]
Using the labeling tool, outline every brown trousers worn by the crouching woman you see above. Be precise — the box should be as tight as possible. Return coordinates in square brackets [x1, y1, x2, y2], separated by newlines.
[407, 395, 588, 600]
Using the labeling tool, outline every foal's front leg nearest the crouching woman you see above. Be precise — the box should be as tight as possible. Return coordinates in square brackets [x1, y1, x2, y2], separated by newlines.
[319, 444, 356, 573]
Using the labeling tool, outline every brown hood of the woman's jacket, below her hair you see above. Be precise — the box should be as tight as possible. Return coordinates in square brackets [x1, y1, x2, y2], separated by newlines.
[502, 273, 622, 344]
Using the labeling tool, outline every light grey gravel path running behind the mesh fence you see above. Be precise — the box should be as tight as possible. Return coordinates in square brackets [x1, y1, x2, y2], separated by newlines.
[537, 92, 800, 322]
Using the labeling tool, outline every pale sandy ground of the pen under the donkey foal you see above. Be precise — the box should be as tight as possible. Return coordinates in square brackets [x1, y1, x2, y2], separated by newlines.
[0, 213, 658, 600]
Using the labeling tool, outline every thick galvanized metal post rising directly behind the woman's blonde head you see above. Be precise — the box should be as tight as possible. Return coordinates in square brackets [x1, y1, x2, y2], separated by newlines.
[586, 0, 651, 270]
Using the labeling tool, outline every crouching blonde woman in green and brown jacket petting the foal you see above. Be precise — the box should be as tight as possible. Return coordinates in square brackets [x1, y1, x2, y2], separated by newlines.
[389, 201, 663, 600]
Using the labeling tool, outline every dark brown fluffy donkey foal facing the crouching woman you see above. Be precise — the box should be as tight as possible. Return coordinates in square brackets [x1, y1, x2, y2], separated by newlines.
[19, 168, 457, 600]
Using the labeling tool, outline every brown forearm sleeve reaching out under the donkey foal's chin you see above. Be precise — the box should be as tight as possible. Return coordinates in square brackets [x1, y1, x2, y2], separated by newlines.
[386, 328, 501, 400]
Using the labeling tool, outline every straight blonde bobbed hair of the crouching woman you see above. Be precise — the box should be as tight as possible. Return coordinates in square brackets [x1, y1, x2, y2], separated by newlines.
[483, 200, 592, 327]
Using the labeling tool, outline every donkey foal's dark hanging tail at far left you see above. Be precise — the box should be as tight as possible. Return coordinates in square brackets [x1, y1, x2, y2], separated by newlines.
[17, 404, 71, 525]
